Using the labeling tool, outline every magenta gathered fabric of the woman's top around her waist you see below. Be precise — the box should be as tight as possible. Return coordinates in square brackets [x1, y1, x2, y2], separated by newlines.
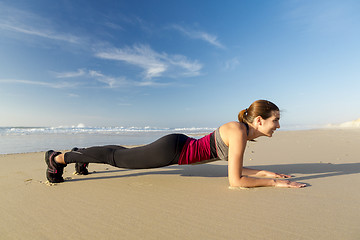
[179, 133, 213, 165]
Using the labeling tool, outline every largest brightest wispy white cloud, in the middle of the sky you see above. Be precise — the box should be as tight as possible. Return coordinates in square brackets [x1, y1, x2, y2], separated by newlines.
[95, 44, 202, 79]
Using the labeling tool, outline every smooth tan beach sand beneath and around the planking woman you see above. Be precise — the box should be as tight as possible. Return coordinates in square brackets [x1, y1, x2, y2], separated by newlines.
[0, 130, 360, 240]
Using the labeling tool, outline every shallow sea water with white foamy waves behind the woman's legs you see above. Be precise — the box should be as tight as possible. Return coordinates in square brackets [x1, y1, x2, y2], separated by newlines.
[0, 125, 215, 154]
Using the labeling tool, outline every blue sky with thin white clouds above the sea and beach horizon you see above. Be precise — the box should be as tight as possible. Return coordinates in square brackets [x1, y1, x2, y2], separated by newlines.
[0, 0, 360, 129]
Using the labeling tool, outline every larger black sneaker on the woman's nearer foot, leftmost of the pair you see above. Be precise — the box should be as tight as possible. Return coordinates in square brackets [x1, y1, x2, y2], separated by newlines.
[45, 150, 66, 183]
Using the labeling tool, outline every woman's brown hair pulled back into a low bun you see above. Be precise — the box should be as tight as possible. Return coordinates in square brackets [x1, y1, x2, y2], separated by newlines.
[238, 100, 279, 124]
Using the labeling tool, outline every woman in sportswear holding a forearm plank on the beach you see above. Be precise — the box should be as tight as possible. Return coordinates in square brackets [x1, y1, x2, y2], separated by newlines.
[45, 100, 306, 188]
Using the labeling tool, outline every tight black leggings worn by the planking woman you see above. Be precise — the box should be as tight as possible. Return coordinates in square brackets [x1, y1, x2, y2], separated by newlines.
[65, 134, 188, 169]
